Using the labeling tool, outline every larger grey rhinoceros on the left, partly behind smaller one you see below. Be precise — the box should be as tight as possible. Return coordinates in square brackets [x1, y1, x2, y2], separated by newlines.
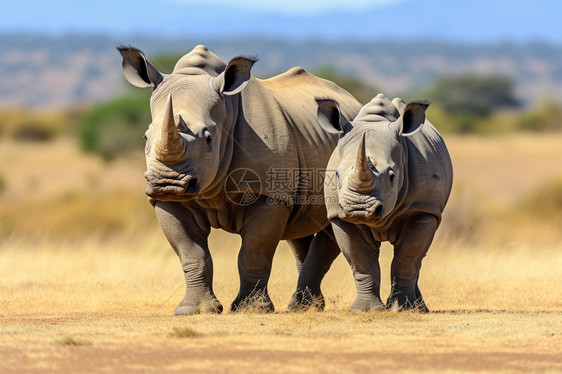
[119, 46, 361, 314]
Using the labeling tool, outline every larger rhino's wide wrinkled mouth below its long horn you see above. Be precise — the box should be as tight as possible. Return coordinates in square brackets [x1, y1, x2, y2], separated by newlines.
[144, 170, 199, 201]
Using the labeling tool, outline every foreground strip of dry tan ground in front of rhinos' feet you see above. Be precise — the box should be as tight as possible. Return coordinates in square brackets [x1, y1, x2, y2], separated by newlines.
[0, 311, 562, 373]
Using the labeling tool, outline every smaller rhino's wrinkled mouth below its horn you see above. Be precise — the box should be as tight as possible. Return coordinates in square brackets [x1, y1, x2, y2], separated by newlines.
[338, 191, 384, 224]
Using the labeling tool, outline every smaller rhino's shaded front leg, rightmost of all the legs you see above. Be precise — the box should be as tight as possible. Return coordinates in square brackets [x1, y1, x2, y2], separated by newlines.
[387, 214, 439, 312]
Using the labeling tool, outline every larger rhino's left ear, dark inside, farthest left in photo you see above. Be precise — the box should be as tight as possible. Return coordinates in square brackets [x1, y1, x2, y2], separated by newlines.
[117, 46, 164, 89]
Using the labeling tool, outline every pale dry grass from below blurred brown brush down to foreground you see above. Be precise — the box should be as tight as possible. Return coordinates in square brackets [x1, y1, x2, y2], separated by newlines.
[0, 238, 562, 373]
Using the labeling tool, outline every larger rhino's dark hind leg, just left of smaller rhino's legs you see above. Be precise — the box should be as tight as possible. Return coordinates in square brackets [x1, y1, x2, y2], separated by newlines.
[289, 225, 340, 311]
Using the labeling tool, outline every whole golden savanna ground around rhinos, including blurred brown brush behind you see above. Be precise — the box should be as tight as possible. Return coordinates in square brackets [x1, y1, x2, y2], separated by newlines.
[0, 134, 562, 373]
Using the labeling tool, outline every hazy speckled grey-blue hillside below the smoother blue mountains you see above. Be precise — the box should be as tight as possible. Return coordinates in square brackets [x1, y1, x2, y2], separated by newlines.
[0, 34, 562, 108]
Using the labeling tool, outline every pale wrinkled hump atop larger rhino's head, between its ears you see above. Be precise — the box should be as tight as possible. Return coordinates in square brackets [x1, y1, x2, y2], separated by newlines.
[174, 45, 226, 76]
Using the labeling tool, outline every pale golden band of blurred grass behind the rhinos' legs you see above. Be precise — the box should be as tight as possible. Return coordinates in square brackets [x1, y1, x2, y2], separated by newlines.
[0, 231, 562, 316]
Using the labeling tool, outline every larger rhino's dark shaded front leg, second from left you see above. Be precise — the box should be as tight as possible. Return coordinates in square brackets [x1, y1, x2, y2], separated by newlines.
[230, 199, 289, 312]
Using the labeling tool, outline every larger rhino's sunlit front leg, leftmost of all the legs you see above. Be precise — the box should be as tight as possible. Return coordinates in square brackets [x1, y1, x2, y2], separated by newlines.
[155, 201, 222, 314]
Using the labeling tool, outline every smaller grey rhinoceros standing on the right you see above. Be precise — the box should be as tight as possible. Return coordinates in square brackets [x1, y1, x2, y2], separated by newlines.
[317, 94, 453, 312]
